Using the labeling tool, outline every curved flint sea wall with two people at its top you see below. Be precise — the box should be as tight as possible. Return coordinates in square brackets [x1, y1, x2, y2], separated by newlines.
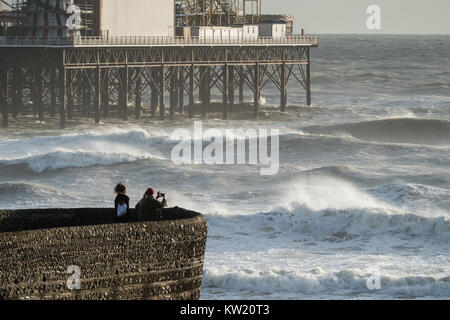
[0, 208, 207, 300]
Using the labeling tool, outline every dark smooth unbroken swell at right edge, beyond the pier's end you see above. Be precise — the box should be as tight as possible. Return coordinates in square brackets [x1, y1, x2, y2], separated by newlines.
[302, 118, 450, 146]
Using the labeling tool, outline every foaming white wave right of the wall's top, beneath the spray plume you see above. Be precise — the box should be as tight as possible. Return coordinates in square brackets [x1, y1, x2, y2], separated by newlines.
[209, 204, 450, 241]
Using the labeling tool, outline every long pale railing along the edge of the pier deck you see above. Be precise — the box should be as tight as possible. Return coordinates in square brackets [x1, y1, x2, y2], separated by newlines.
[0, 36, 318, 47]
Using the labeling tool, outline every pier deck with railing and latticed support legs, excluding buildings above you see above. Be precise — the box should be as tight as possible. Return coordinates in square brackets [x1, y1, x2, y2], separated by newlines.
[0, 37, 318, 128]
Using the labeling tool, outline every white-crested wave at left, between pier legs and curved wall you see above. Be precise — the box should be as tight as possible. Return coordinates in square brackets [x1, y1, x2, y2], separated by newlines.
[0, 129, 175, 173]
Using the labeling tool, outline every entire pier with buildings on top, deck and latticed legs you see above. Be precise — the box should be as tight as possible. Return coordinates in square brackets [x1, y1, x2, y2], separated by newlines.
[0, 0, 318, 128]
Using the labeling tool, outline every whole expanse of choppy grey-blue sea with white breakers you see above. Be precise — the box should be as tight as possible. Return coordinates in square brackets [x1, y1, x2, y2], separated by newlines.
[0, 36, 450, 299]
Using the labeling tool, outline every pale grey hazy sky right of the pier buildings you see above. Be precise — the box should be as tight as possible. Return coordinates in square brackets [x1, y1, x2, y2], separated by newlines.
[262, 0, 450, 34]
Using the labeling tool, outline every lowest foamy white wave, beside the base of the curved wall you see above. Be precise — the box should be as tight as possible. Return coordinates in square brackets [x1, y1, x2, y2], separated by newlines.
[203, 267, 450, 298]
